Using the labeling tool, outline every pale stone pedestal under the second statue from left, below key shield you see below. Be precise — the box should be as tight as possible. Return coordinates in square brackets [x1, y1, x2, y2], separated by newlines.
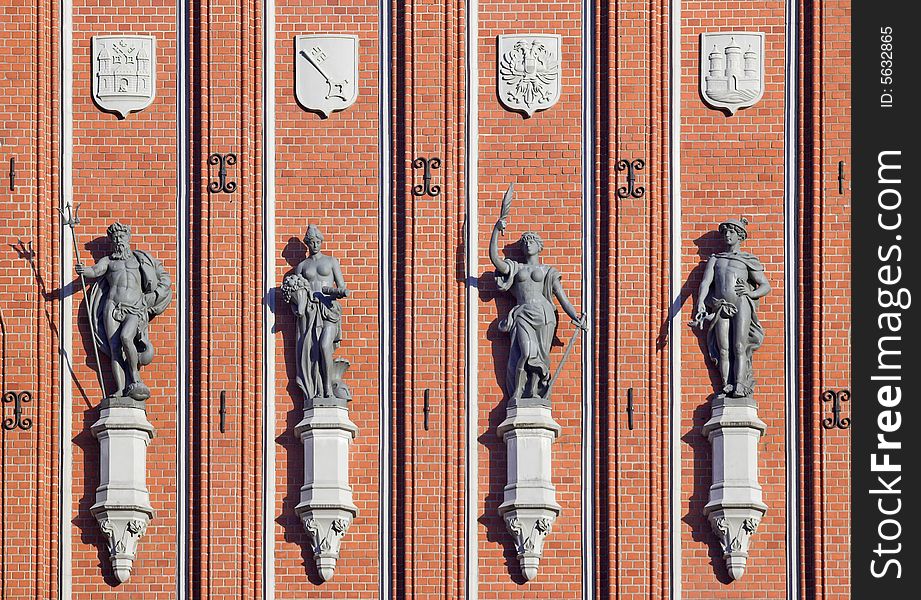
[294, 398, 358, 581]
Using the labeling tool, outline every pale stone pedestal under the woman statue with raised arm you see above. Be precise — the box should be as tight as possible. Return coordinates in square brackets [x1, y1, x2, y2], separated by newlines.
[498, 398, 560, 581]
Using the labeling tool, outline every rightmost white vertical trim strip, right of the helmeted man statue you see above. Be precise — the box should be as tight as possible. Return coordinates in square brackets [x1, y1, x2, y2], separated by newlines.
[784, 0, 800, 600]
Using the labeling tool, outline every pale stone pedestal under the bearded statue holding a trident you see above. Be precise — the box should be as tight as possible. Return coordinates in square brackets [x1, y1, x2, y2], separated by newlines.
[90, 398, 154, 583]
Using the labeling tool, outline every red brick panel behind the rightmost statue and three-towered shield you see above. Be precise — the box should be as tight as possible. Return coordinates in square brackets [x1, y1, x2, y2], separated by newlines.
[676, 2, 795, 600]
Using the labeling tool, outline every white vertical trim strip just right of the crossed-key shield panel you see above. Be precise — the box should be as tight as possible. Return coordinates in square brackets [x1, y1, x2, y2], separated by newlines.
[377, 0, 393, 600]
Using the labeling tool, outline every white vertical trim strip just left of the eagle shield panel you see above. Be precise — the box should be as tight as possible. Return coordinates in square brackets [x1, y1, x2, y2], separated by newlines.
[464, 0, 480, 600]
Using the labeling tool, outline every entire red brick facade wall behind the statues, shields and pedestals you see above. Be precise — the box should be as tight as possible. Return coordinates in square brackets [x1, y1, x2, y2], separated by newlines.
[0, 0, 850, 600]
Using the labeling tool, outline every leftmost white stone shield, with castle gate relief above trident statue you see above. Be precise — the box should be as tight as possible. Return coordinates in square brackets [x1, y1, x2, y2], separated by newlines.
[92, 35, 157, 119]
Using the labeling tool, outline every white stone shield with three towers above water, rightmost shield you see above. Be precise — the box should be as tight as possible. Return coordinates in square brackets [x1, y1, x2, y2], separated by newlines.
[700, 31, 764, 115]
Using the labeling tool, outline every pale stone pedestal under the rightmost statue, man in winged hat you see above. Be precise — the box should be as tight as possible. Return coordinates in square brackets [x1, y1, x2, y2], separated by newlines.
[703, 396, 768, 579]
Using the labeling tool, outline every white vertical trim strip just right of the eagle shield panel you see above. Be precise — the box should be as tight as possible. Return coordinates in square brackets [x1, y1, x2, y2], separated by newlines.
[581, 0, 595, 599]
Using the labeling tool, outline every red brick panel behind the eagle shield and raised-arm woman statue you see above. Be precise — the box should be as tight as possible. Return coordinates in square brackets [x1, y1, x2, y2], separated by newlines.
[471, 0, 588, 599]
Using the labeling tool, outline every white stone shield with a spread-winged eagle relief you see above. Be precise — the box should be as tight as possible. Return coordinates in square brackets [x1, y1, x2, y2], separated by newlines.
[496, 33, 562, 117]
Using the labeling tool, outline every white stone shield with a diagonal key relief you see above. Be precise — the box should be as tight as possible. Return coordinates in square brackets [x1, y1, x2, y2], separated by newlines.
[294, 35, 358, 117]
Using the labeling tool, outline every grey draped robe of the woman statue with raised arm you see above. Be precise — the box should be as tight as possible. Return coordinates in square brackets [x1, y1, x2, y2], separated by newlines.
[496, 259, 560, 397]
